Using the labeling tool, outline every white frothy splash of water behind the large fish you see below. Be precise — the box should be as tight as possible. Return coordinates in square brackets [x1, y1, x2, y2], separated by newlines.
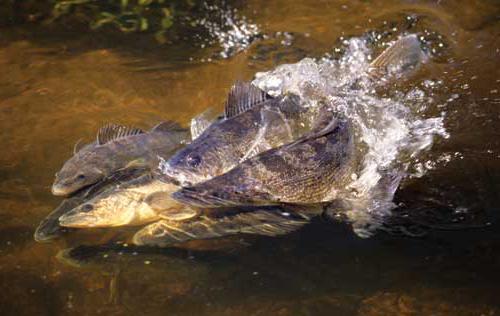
[253, 38, 448, 237]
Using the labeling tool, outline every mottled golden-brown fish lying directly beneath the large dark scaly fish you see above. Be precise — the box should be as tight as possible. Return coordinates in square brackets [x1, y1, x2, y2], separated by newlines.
[132, 207, 310, 247]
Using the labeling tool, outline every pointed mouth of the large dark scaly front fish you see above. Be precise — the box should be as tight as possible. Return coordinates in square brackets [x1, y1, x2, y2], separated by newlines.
[172, 188, 241, 208]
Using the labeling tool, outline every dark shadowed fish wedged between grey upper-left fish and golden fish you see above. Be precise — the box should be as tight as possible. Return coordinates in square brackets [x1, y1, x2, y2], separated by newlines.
[33, 168, 147, 242]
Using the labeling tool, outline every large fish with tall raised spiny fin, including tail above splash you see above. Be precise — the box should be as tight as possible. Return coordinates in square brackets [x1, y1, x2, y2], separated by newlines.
[160, 35, 425, 186]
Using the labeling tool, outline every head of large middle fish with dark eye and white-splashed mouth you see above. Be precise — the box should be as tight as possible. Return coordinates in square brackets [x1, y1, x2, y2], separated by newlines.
[160, 142, 227, 186]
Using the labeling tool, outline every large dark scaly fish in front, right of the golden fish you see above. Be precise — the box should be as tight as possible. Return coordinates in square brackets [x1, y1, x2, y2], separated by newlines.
[172, 111, 356, 208]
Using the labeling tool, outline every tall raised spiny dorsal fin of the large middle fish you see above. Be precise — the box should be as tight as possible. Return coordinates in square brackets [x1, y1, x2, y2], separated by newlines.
[224, 81, 271, 118]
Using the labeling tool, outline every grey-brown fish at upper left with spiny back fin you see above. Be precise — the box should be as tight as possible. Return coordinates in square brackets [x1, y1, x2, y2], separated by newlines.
[52, 121, 190, 196]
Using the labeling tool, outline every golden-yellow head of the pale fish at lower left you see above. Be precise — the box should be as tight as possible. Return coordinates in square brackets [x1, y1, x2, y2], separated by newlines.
[59, 193, 140, 228]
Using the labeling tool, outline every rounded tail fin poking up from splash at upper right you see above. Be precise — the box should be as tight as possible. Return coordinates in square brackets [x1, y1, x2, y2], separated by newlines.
[370, 35, 425, 75]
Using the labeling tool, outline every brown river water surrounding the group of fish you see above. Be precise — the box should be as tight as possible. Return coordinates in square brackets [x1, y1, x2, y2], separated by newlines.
[0, 0, 500, 315]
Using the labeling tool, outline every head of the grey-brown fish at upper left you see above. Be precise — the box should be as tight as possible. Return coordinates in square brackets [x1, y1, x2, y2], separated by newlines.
[52, 154, 105, 196]
